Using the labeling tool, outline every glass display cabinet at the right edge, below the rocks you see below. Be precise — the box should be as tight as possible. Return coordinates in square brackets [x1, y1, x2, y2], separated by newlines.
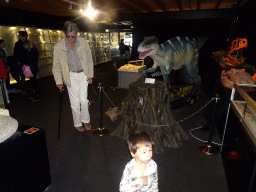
[230, 84, 256, 145]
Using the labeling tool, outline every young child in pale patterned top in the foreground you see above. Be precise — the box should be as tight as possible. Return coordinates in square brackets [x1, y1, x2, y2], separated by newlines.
[119, 132, 158, 192]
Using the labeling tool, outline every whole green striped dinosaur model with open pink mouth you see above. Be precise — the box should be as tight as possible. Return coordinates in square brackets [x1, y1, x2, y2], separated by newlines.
[138, 36, 208, 88]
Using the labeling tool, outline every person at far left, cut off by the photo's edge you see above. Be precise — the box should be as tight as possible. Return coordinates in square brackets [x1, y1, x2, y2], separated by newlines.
[0, 39, 10, 103]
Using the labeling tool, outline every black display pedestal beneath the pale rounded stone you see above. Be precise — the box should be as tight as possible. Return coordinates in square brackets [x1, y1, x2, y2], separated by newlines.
[0, 125, 51, 192]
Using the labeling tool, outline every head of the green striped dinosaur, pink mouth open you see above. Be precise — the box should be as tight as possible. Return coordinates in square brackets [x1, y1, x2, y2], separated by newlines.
[138, 36, 159, 59]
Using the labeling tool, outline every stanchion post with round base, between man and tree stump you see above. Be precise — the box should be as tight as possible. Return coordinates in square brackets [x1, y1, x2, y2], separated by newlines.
[92, 83, 109, 136]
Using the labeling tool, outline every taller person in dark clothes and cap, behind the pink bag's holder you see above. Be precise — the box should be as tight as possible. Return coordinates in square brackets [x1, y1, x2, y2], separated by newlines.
[12, 31, 28, 93]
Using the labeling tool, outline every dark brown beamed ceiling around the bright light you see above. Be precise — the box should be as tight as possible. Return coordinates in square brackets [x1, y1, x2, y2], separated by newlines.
[0, 0, 250, 25]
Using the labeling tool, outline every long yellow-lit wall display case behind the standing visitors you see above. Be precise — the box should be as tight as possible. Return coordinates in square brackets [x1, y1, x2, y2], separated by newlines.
[0, 26, 111, 79]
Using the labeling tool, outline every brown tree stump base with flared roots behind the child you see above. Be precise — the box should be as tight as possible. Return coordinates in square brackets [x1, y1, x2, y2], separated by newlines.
[111, 78, 188, 153]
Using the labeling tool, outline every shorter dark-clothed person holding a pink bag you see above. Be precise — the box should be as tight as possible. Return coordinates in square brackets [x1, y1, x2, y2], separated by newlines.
[23, 41, 41, 101]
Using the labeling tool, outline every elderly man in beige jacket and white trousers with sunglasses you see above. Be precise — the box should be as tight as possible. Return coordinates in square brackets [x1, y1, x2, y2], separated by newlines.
[52, 21, 94, 132]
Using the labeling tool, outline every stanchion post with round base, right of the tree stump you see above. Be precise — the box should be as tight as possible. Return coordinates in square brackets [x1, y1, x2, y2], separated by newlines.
[198, 95, 220, 155]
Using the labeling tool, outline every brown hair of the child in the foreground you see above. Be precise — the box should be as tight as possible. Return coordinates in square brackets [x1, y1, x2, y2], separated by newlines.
[127, 131, 154, 154]
